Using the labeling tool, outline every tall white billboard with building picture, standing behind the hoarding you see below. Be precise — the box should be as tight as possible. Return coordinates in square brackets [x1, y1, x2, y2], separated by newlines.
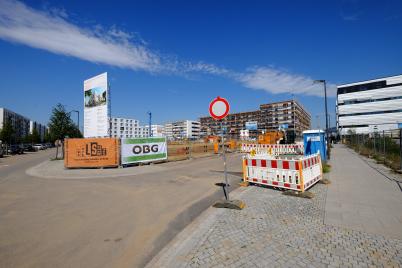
[84, 73, 110, 138]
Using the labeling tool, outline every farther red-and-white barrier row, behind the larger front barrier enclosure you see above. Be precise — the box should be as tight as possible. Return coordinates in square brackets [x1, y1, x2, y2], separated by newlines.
[241, 143, 304, 155]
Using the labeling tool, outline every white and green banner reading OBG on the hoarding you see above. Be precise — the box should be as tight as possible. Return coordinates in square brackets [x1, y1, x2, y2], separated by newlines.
[121, 137, 167, 165]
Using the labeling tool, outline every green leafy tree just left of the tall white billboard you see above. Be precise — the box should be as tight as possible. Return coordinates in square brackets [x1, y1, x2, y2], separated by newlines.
[49, 103, 82, 159]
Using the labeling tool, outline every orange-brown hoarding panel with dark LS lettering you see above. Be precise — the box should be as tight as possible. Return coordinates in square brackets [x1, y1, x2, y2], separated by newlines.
[64, 138, 120, 168]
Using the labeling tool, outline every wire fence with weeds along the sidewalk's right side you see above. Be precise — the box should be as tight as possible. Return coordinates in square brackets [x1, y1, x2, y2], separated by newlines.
[343, 129, 402, 170]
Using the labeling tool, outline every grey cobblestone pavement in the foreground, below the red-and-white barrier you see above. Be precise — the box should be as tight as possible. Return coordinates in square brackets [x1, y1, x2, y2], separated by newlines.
[149, 184, 402, 267]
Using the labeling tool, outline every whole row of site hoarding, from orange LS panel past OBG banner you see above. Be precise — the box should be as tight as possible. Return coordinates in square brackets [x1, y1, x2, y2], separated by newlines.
[64, 137, 237, 168]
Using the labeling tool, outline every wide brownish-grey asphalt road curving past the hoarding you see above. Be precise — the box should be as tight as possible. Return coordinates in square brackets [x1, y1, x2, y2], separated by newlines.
[0, 150, 241, 267]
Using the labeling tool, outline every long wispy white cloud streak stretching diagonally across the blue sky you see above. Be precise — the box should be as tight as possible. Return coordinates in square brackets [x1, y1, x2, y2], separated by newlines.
[0, 0, 335, 96]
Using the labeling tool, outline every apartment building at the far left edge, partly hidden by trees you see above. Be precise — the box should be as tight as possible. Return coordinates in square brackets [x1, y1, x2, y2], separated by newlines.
[0, 108, 30, 143]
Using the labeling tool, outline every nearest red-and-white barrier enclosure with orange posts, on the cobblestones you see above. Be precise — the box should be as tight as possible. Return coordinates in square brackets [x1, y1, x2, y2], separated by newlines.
[243, 154, 322, 192]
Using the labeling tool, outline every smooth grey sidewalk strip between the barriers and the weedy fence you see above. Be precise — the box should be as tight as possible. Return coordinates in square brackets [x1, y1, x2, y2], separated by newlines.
[325, 144, 402, 239]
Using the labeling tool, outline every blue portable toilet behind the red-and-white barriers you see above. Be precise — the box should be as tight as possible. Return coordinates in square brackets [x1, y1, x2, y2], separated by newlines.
[303, 129, 327, 161]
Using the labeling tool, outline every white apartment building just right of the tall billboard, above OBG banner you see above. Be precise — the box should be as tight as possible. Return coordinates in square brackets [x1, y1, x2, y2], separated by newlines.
[111, 117, 149, 138]
